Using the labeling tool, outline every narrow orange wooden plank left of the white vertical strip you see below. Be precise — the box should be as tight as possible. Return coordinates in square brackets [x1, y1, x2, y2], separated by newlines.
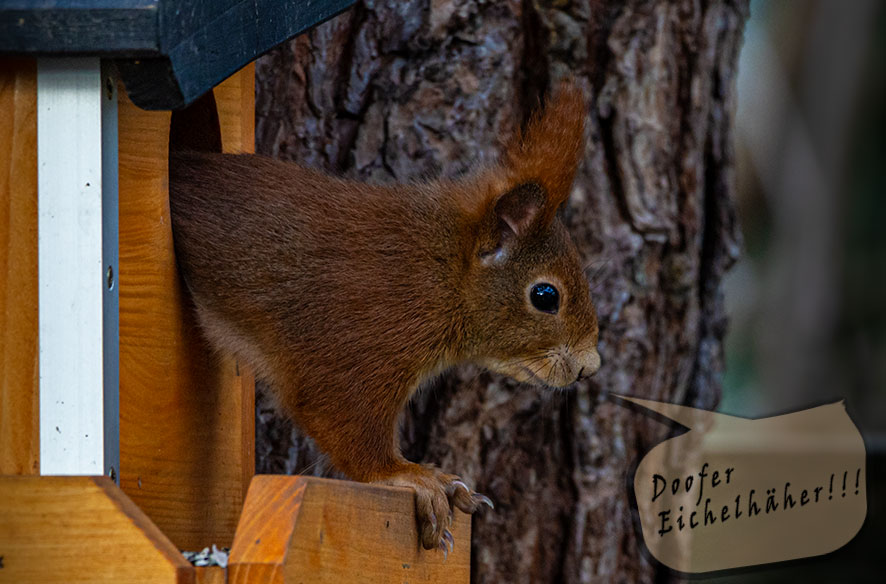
[0, 59, 40, 474]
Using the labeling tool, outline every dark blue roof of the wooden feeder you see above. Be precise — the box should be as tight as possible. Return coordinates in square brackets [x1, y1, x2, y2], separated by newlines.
[0, 0, 354, 109]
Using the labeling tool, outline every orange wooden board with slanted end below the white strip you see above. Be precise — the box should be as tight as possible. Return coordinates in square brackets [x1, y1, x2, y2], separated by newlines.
[0, 476, 194, 583]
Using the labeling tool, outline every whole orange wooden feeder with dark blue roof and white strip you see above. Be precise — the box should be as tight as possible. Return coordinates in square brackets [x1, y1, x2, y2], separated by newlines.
[0, 0, 470, 584]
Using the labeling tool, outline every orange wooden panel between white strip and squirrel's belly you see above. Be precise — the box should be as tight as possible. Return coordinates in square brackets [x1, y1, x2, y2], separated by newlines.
[119, 66, 255, 550]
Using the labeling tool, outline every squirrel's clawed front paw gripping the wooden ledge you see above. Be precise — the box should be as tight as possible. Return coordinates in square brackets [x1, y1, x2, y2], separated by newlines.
[379, 464, 495, 555]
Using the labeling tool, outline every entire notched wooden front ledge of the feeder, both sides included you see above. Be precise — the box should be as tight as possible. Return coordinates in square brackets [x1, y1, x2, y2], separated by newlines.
[0, 475, 471, 584]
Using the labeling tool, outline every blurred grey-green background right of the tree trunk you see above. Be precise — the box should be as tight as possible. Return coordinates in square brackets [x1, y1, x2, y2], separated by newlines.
[716, 0, 886, 582]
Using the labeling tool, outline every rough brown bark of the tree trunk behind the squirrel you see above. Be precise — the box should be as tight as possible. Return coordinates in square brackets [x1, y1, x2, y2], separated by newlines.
[256, 0, 748, 582]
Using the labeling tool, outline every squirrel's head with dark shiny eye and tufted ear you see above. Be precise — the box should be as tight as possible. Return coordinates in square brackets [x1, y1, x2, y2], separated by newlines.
[454, 78, 600, 387]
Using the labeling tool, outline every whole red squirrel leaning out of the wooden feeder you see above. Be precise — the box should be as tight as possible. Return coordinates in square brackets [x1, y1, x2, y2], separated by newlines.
[170, 83, 600, 551]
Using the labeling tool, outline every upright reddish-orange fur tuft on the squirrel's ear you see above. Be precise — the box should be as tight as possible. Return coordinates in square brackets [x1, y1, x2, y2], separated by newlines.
[502, 80, 586, 228]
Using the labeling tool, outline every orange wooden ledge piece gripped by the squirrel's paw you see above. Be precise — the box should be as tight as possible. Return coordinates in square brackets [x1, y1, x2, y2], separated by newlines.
[228, 475, 471, 584]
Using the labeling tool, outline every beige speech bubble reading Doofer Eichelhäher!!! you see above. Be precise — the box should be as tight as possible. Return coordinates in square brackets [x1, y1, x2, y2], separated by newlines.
[616, 396, 867, 573]
